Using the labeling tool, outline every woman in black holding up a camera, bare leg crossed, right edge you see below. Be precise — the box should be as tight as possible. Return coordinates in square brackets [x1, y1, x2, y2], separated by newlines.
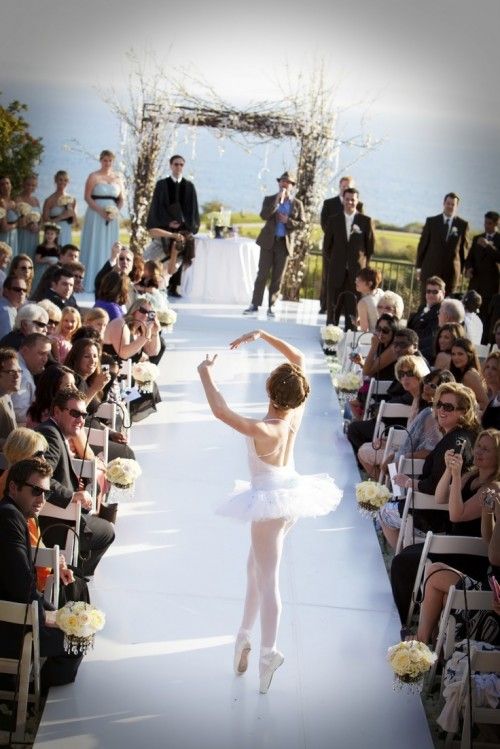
[410, 429, 500, 645]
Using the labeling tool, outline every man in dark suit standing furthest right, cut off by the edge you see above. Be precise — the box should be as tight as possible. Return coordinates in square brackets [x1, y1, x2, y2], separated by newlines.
[465, 211, 500, 343]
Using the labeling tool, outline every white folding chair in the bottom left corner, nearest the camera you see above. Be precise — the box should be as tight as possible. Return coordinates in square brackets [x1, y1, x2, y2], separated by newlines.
[0, 601, 40, 742]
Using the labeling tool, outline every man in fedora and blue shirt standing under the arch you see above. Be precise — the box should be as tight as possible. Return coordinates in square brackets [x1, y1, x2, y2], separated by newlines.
[243, 172, 305, 317]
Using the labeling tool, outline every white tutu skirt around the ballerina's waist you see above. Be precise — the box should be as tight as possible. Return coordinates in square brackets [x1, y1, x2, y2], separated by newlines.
[216, 466, 342, 522]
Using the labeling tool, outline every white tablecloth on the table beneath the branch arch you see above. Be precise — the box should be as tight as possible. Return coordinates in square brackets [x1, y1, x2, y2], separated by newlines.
[181, 237, 260, 305]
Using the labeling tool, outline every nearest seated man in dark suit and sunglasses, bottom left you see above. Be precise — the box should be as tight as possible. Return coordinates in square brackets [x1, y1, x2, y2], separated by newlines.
[0, 458, 83, 689]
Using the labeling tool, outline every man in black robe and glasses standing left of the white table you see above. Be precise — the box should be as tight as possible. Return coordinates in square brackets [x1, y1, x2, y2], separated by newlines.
[146, 154, 200, 297]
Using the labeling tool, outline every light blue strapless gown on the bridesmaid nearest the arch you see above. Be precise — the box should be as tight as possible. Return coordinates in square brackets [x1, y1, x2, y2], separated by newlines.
[80, 182, 120, 292]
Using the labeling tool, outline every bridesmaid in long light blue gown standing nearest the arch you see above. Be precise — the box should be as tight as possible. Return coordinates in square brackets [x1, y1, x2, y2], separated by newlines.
[80, 150, 124, 291]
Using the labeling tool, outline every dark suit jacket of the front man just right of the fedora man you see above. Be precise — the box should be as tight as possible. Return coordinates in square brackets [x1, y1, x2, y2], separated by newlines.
[323, 211, 375, 280]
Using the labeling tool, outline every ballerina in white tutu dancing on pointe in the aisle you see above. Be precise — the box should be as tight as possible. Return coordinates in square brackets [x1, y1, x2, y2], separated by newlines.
[198, 330, 342, 694]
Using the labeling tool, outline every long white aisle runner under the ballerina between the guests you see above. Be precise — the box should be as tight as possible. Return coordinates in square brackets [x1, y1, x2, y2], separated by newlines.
[35, 305, 432, 749]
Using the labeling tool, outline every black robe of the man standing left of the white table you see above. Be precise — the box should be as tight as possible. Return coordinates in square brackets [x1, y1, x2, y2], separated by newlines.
[146, 177, 200, 234]
